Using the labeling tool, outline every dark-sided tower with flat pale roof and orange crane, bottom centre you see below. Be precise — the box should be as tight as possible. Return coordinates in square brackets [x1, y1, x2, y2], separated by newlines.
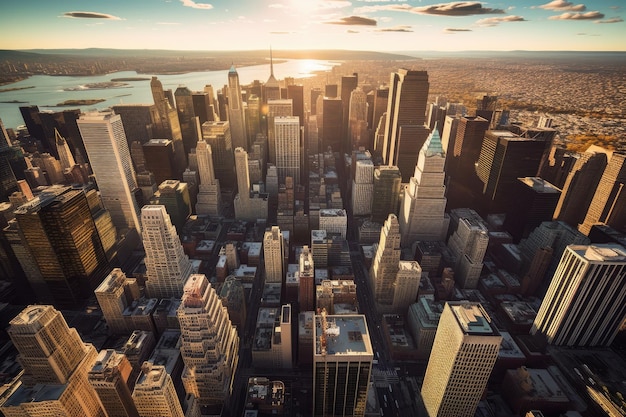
[313, 311, 374, 417]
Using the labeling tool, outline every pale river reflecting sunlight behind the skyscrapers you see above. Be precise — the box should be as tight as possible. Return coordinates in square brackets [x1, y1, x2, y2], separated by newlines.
[0, 59, 340, 128]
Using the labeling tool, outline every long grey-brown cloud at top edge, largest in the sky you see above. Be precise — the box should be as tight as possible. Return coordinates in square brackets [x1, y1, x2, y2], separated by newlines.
[355, 1, 504, 16]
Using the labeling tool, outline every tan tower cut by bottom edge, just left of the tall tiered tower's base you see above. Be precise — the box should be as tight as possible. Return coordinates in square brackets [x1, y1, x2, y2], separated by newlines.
[133, 362, 185, 417]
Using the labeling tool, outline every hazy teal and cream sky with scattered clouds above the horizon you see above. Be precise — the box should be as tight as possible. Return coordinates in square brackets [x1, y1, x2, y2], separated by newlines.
[0, 0, 626, 52]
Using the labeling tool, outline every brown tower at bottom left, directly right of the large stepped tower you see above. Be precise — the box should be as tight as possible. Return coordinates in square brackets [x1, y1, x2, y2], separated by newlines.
[88, 349, 139, 417]
